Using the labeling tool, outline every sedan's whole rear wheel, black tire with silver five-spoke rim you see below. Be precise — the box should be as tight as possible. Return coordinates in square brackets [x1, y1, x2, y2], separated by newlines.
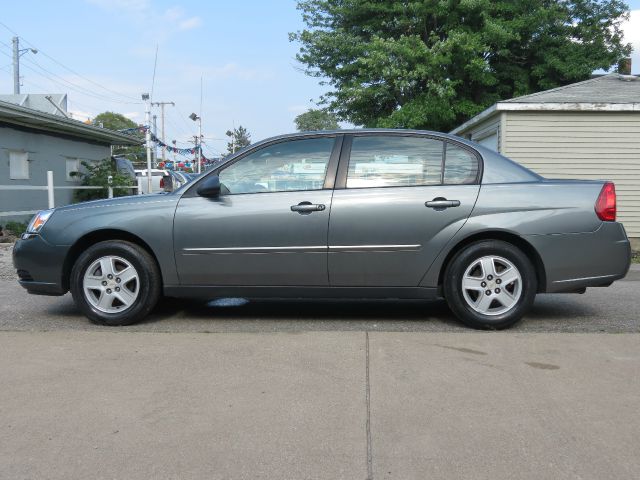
[444, 240, 537, 330]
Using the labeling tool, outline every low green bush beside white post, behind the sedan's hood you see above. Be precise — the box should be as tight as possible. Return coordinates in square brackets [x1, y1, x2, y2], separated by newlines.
[71, 158, 133, 202]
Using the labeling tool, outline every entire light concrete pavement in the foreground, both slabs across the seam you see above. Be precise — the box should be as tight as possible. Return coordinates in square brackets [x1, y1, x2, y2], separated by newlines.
[0, 329, 640, 480]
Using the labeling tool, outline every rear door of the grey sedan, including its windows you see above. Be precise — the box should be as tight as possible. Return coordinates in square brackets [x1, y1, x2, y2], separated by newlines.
[329, 134, 481, 287]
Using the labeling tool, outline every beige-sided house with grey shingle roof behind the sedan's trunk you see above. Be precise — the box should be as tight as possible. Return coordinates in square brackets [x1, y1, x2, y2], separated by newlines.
[451, 73, 640, 250]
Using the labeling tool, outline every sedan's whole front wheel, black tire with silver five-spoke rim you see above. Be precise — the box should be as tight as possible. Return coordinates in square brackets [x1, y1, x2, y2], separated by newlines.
[70, 241, 161, 326]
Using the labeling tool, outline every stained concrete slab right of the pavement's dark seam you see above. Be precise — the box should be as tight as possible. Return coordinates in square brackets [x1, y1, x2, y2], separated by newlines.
[371, 333, 640, 480]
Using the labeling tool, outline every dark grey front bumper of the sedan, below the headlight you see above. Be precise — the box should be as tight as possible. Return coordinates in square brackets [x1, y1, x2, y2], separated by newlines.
[13, 235, 69, 295]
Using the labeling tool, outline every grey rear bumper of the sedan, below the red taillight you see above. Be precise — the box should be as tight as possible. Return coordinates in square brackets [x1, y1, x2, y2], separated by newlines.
[525, 222, 631, 293]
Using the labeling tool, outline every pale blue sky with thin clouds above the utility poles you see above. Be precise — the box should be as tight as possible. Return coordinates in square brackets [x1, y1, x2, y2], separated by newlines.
[0, 0, 640, 155]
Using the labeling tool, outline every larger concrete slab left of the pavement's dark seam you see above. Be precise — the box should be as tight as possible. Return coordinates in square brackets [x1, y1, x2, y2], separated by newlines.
[0, 332, 366, 480]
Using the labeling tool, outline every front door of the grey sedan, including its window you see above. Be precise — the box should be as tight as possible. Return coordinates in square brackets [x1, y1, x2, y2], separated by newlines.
[174, 137, 338, 286]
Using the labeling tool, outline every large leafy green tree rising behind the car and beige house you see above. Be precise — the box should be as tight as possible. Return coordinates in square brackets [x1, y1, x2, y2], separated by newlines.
[290, 0, 630, 131]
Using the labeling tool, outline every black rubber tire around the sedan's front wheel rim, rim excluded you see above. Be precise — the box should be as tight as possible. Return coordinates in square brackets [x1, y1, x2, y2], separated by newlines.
[70, 240, 162, 326]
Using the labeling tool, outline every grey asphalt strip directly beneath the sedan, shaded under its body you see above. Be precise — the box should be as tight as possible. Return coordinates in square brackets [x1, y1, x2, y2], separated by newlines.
[0, 264, 640, 333]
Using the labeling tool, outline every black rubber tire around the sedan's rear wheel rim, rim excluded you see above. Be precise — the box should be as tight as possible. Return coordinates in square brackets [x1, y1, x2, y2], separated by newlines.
[443, 240, 538, 330]
